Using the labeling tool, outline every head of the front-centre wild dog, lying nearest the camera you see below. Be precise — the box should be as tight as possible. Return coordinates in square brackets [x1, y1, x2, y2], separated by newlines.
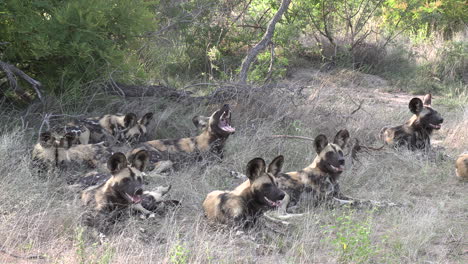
[246, 156, 285, 207]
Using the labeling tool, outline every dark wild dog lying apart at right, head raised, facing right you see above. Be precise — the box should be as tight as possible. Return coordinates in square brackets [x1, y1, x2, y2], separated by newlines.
[380, 94, 444, 151]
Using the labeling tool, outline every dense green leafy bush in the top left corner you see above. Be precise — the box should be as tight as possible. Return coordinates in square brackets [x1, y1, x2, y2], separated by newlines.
[0, 0, 152, 98]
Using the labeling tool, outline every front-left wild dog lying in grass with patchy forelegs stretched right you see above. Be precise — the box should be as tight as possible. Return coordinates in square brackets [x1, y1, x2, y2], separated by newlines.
[81, 150, 179, 227]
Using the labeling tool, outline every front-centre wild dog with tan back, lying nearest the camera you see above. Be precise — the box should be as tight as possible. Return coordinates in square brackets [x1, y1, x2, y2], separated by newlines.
[203, 156, 285, 225]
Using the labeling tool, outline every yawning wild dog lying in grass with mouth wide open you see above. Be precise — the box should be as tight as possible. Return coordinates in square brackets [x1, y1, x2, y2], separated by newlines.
[142, 104, 235, 164]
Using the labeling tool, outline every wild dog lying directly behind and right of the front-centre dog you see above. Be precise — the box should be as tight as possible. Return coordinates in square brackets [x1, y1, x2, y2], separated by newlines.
[278, 129, 349, 215]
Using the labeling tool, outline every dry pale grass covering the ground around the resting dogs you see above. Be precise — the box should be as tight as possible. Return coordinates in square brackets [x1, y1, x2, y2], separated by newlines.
[0, 70, 468, 263]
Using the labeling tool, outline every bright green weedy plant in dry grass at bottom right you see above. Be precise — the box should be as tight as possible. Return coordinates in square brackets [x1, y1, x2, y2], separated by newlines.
[327, 211, 379, 263]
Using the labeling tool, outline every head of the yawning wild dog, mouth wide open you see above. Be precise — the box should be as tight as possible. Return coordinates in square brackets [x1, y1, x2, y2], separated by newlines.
[192, 104, 236, 137]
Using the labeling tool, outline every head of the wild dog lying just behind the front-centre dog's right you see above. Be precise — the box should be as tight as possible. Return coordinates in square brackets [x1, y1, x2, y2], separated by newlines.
[314, 129, 349, 174]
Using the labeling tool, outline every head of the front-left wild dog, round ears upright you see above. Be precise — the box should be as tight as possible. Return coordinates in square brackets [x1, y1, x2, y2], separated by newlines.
[107, 150, 148, 204]
